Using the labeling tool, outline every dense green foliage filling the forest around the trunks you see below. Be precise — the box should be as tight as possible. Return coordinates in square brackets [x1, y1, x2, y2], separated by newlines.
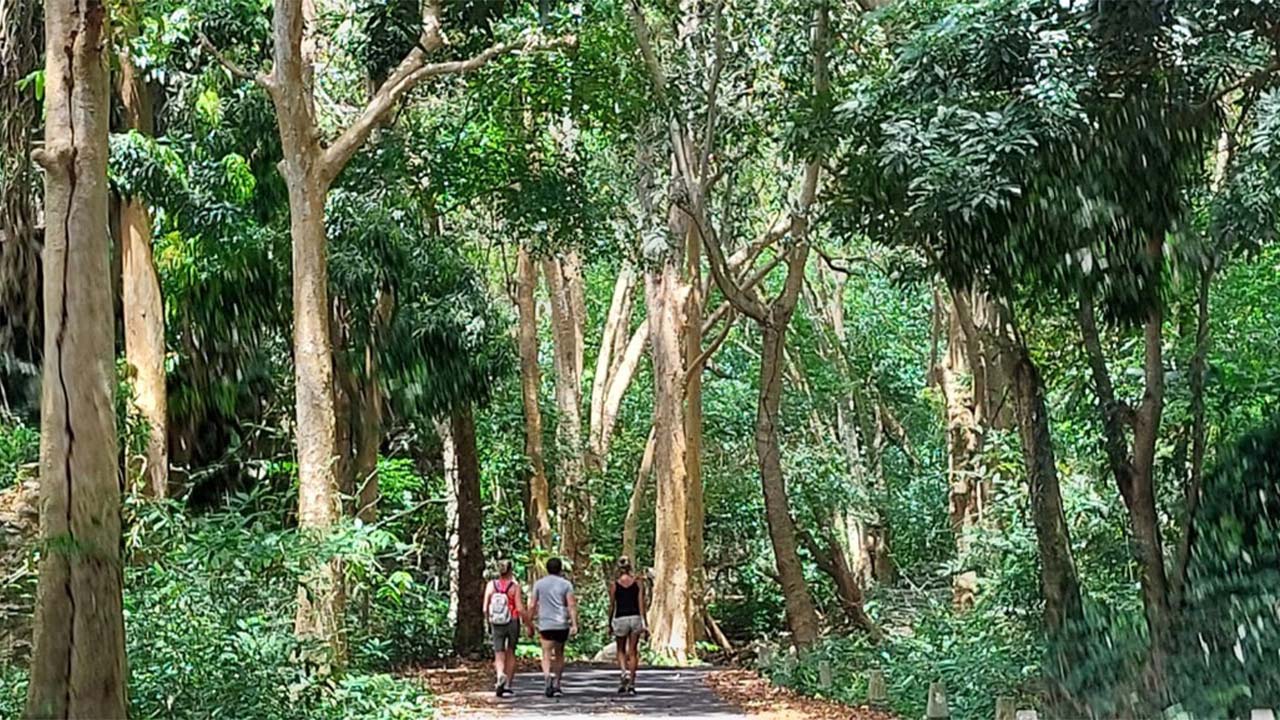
[0, 0, 1280, 720]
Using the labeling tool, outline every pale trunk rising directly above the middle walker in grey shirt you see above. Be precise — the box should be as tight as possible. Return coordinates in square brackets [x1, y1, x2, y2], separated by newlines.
[543, 254, 590, 573]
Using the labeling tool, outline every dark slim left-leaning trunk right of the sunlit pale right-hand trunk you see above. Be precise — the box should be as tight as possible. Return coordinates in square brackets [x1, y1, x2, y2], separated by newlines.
[1010, 337, 1083, 634]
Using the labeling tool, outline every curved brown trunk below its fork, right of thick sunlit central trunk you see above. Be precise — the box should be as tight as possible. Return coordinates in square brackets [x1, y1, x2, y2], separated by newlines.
[755, 323, 818, 647]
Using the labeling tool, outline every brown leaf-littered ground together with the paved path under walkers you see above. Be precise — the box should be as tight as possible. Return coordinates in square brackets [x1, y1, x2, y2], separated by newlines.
[420, 660, 891, 720]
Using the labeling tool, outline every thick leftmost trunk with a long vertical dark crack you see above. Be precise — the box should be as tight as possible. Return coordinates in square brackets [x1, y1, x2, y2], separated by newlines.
[26, 0, 127, 719]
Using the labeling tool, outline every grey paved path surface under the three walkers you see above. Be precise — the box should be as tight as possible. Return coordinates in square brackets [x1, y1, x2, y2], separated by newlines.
[444, 666, 746, 720]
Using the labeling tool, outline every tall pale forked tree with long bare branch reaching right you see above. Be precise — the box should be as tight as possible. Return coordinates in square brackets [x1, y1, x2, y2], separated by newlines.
[205, 0, 571, 661]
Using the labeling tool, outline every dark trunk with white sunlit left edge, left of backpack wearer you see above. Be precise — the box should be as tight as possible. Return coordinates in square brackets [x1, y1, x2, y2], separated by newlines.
[450, 406, 485, 656]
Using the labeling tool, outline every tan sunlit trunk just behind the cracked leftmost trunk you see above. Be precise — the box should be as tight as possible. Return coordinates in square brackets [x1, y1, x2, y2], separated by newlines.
[118, 41, 169, 498]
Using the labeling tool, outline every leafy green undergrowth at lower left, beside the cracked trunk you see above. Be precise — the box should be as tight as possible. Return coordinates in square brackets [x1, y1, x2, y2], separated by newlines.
[0, 493, 444, 720]
